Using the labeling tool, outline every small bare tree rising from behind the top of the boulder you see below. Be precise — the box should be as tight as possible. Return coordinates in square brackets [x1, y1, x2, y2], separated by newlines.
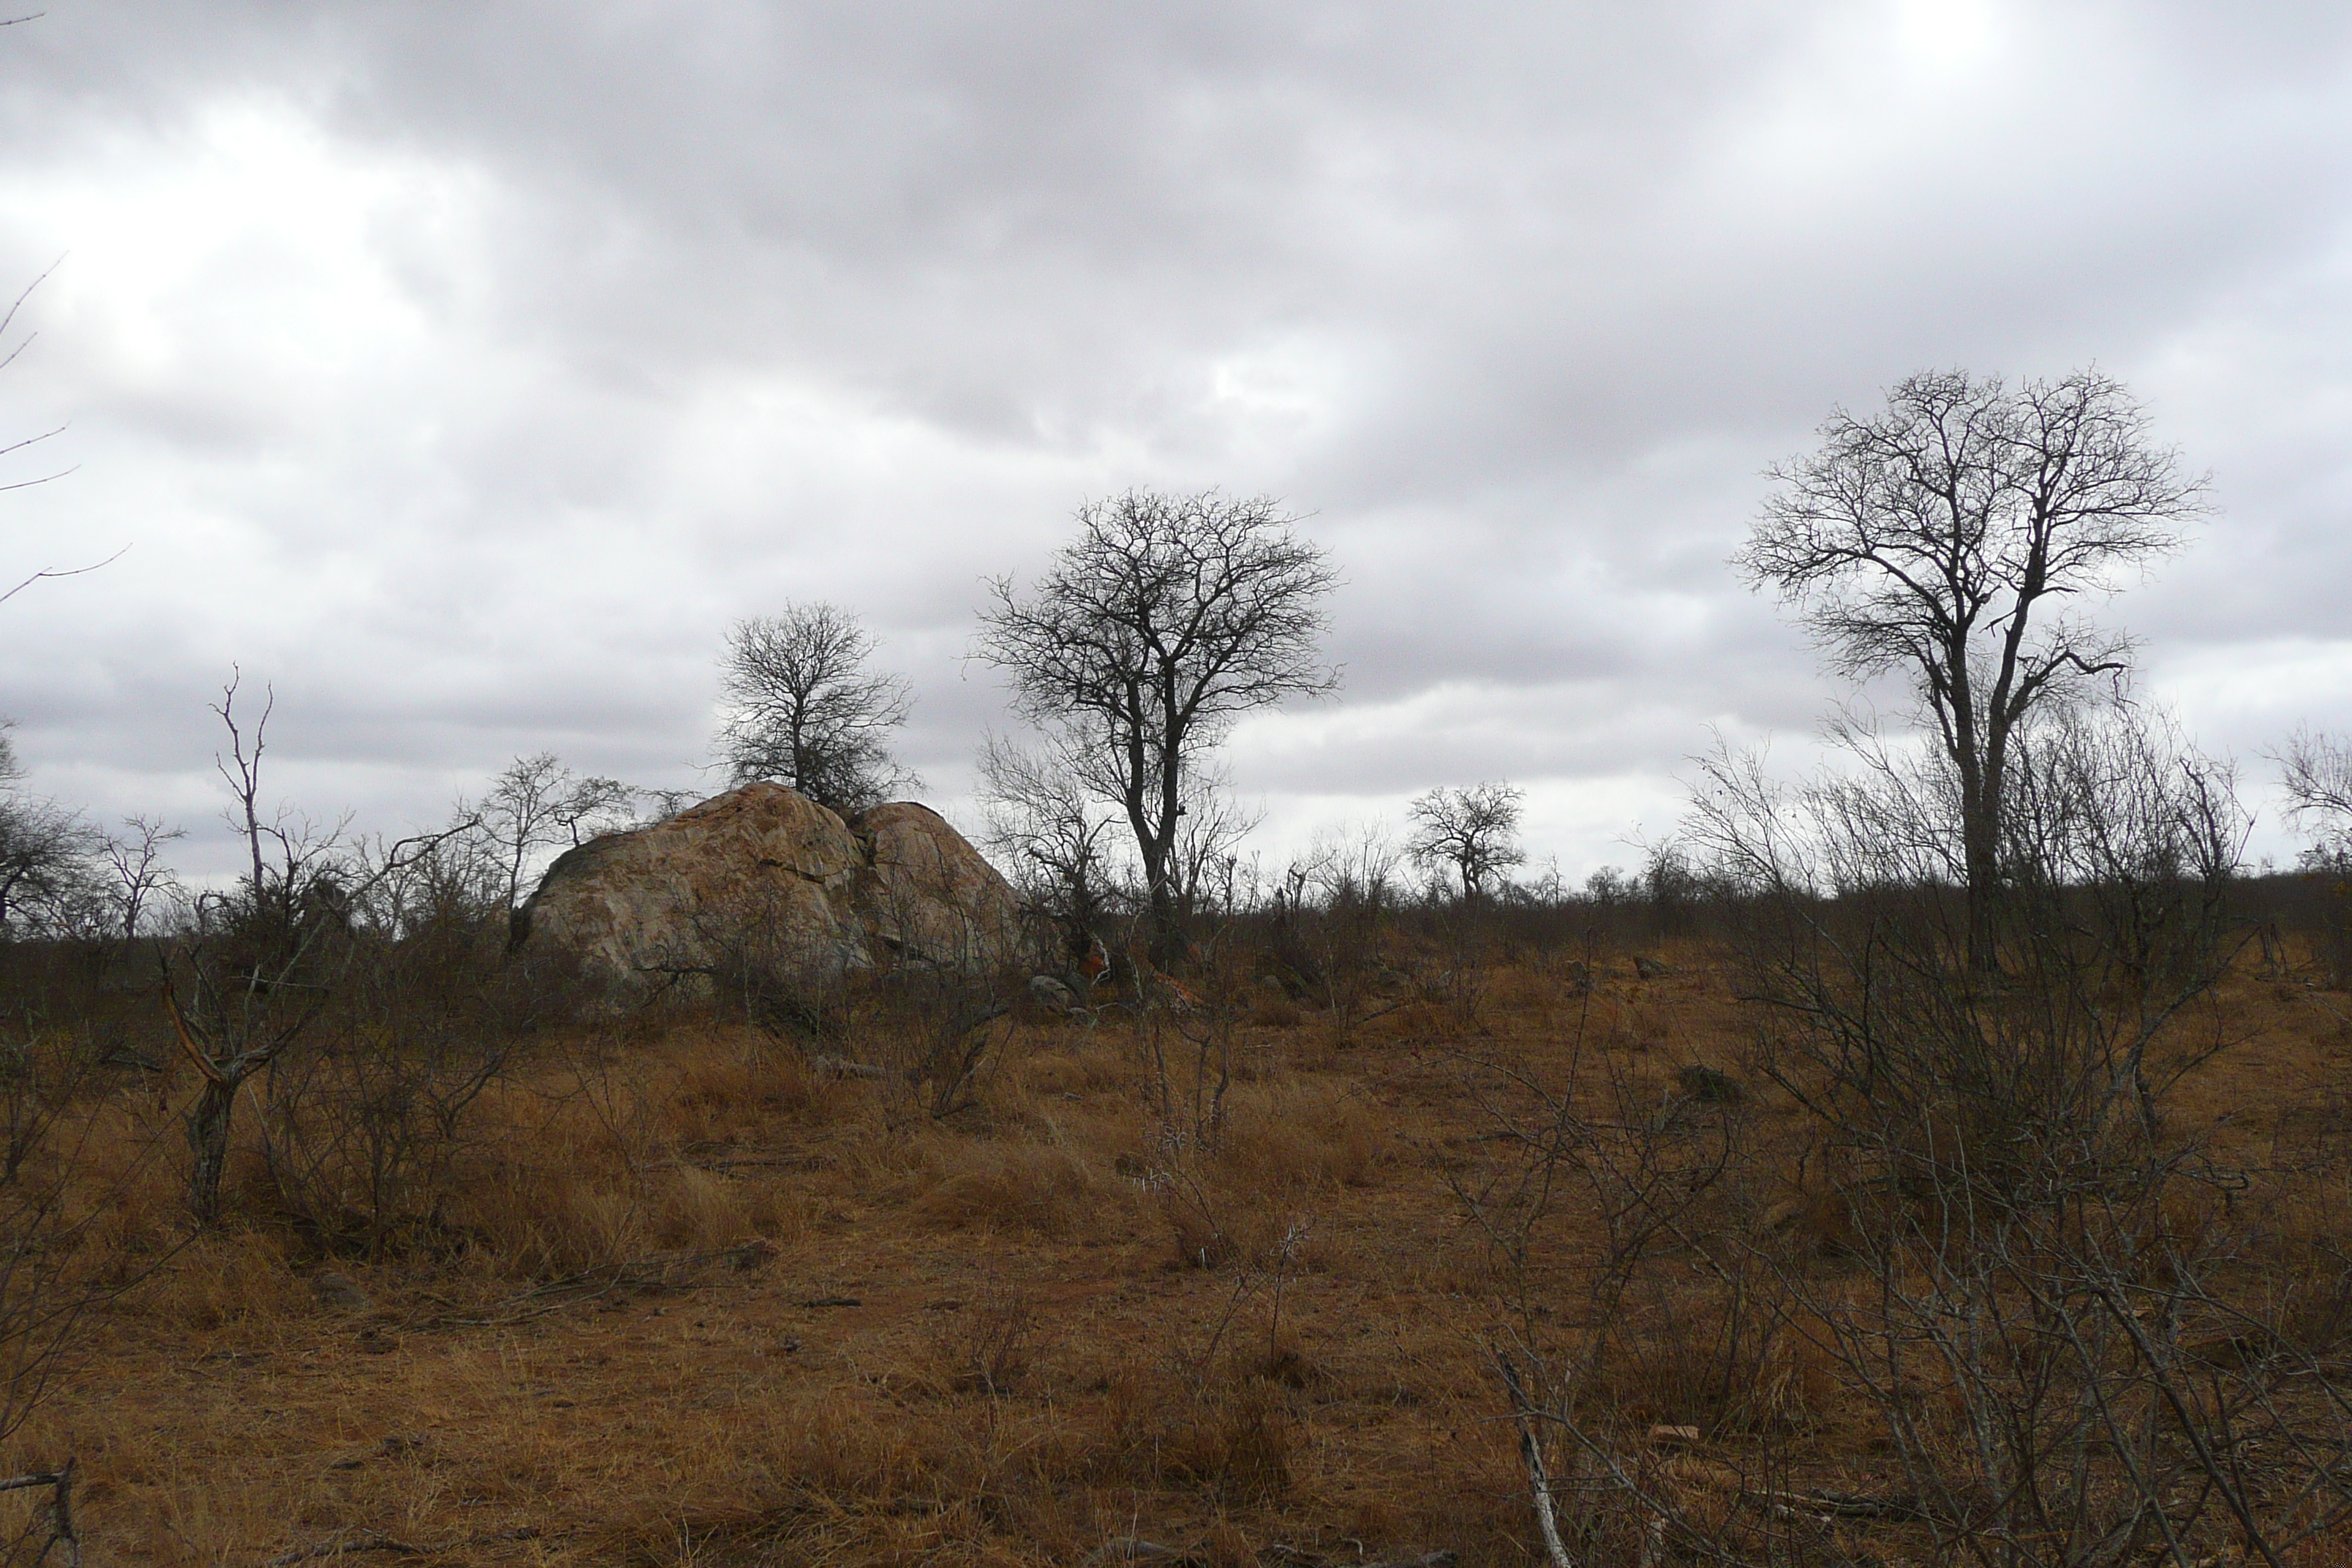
[717, 602, 915, 815]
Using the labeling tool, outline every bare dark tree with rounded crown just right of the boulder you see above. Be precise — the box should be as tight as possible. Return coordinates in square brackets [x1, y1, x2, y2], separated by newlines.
[979, 489, 1338, 957]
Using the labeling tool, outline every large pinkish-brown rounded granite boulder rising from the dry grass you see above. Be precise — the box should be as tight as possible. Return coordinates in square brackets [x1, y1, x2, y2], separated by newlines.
[518, 783, 1019, 978]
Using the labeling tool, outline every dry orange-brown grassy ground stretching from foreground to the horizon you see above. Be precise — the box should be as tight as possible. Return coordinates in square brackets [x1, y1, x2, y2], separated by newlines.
[0, 864, 2352, 1566]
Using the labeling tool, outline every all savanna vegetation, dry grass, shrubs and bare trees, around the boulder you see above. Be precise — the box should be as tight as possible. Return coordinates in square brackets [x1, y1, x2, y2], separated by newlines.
[0, 423, 2352, 1568]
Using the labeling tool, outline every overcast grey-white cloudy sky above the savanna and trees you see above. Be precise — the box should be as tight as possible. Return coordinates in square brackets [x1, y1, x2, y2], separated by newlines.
[0, 0, 2352, 875]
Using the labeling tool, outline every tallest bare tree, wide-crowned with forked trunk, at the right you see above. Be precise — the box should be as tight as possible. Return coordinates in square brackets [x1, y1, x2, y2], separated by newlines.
[1733, 369, 2204, 968]
